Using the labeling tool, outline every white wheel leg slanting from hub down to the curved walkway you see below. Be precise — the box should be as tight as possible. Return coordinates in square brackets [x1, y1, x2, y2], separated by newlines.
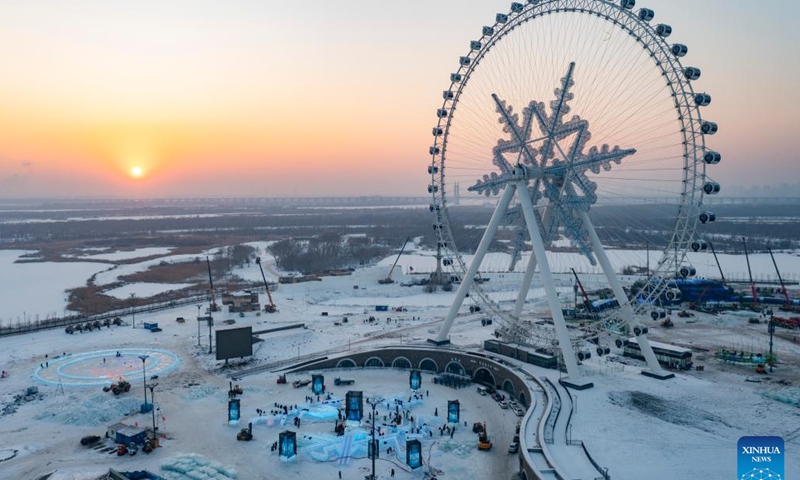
[517, 180, 591, 382]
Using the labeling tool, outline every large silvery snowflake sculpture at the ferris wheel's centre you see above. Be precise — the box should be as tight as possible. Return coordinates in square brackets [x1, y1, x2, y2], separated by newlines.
[469, 62, 636, 271]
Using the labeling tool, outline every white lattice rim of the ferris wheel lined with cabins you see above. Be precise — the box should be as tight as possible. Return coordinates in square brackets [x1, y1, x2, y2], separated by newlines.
[429, 0, 709, 336]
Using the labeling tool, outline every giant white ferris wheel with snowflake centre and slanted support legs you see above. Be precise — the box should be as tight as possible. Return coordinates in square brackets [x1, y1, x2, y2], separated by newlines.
[428, 0, 721, 377]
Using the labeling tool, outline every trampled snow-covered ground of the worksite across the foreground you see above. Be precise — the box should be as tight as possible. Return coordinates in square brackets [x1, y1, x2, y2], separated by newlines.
[0, 248, 800, 480]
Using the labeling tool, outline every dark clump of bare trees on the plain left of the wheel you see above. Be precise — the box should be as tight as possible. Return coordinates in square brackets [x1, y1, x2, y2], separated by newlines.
[269, 232, 391, 275]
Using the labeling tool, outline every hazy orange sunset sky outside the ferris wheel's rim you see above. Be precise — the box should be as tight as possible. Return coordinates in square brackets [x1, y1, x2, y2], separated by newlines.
[0, 0, 800, 197]
